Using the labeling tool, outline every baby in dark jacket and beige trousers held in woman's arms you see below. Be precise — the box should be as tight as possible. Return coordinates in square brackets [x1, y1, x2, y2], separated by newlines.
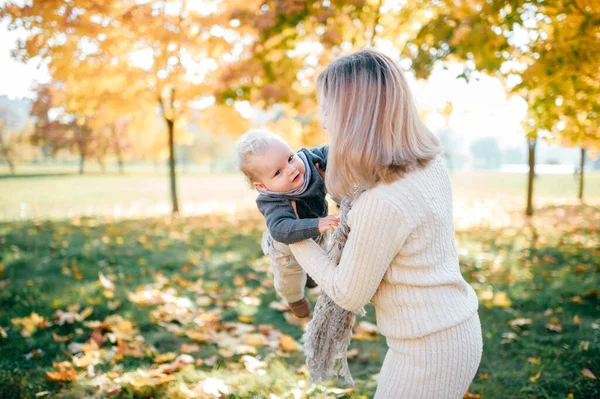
[236, 130, 339, 317]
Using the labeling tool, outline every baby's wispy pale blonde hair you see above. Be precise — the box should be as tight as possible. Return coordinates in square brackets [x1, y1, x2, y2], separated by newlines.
[235, 129, 288, 185]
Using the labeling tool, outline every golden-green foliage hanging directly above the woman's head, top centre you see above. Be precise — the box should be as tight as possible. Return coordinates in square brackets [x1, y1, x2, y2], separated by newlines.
[217, 0, 432, 133]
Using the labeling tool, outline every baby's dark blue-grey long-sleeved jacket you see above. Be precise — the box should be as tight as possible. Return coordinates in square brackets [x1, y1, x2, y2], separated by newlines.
[256, 145, 329, 244]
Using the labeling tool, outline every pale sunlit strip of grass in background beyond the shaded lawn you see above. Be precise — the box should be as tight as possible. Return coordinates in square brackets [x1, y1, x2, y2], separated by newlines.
[0, 168, 600, 220]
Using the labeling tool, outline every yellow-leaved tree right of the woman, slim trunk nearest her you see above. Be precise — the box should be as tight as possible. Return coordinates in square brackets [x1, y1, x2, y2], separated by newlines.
[405, 0, 600, 215]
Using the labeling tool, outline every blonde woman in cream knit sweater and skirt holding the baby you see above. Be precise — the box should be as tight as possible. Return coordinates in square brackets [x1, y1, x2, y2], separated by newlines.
[290, 50, 482, 399]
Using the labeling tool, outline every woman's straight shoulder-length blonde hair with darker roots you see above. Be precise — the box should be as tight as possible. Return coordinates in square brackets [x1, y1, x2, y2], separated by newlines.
[317, 49, 441, 198]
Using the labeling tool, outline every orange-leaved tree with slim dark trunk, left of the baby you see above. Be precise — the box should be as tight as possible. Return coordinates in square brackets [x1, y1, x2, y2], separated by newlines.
[1, 0, 234, 214]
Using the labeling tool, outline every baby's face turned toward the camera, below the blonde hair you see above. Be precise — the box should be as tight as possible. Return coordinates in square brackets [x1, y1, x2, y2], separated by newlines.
[251, 142, 305, 193]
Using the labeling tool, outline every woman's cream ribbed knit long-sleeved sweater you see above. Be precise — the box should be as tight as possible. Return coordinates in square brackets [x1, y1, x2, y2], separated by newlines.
[290, 157, 478, 339]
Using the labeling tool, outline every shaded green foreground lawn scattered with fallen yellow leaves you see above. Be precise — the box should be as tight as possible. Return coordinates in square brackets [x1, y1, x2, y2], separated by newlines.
[0, 206, 600, 398]
